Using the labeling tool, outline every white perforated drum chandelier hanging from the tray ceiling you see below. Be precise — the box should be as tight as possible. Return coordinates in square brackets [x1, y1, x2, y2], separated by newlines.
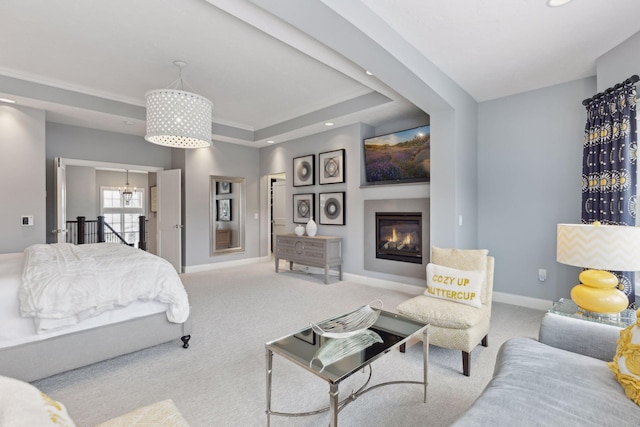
[144, 61, 213, 148]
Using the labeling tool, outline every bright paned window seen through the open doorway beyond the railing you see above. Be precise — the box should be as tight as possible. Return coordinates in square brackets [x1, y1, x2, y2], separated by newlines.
[100, 187, 146, 247]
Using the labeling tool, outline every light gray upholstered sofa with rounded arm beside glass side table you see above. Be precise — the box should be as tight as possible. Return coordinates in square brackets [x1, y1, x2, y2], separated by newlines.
[453, 313, 640, 427]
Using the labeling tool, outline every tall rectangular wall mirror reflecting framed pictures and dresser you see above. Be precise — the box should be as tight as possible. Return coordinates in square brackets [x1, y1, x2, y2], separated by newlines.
[209, 175, 245, 255]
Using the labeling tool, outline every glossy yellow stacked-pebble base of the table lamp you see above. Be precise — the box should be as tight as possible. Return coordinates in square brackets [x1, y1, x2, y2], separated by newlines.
[571, 270, 629, 314]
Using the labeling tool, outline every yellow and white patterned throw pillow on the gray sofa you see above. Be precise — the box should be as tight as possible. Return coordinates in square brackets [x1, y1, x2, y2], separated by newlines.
[608, 312, 640, 405]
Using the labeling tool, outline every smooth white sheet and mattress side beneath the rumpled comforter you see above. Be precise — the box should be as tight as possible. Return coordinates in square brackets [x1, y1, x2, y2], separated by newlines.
[0, 252, 167, 349]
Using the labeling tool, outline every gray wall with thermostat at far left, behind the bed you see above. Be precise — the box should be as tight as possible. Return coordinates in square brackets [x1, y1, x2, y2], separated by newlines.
[0, 103, 46, 253]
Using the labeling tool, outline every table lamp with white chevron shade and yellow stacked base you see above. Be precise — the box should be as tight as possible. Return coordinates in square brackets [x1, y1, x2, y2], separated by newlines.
[556, 222, 640, 315]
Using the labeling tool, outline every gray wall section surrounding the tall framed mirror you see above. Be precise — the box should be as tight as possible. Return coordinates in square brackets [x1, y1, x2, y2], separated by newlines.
[183, 141, 260, 267]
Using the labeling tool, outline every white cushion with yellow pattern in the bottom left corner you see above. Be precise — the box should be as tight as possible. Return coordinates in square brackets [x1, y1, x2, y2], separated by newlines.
[0, 376, 75, 427]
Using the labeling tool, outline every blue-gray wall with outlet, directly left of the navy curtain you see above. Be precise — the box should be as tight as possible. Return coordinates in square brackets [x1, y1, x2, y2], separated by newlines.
[478, 78, 595, 300]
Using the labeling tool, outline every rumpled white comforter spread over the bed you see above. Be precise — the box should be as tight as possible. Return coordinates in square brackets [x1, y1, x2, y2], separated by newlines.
[18, 243, 189, 332]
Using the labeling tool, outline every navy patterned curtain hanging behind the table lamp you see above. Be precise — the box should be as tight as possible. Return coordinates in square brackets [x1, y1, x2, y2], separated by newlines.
[582, 76, 638, 308]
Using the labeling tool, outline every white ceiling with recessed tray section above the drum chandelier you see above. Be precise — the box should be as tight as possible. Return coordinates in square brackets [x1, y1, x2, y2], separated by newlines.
[0, 0, 640, 147]
